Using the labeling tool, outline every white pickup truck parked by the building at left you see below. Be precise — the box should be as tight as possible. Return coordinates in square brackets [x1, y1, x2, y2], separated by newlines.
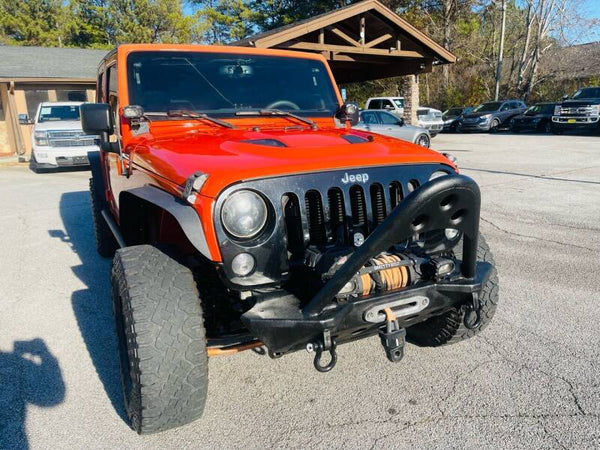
[19, 102, 98, 173]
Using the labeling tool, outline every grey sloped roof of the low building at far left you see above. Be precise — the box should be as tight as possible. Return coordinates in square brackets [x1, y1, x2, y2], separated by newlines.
[0, 45, 108, 81]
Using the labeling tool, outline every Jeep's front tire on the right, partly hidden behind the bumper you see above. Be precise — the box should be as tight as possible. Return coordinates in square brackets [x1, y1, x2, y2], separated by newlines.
[407, 234, 498, 347]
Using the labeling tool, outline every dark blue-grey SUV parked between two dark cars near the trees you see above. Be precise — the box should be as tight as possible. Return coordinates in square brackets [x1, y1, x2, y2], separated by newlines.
[456, 100, 527, 132]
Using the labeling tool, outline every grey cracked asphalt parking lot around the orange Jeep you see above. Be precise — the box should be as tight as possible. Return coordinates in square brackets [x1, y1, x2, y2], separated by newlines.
[0, 134, 600, 449]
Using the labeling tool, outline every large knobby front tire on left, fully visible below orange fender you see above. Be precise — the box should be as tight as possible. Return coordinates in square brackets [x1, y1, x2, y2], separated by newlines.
[111, 245, 208, 434]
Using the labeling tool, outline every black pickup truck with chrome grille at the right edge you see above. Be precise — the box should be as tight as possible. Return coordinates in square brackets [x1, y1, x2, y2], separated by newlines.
[552, 87, 600, 134]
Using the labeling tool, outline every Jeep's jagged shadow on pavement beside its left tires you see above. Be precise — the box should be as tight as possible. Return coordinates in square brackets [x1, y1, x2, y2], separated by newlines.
[48, 191, 128, 423]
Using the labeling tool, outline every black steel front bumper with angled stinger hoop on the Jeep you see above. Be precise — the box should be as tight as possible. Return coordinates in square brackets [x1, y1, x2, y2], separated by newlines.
[242, 175, 491, 354]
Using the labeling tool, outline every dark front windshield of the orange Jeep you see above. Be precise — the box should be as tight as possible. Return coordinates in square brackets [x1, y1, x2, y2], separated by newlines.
[127, 52, 338, 117]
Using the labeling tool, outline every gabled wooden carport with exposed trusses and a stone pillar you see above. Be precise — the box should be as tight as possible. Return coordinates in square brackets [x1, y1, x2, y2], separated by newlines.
[233, 0, 456, 122]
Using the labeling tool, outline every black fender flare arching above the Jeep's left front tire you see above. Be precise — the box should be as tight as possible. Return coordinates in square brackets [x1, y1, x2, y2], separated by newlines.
[119, 185, 212, 260]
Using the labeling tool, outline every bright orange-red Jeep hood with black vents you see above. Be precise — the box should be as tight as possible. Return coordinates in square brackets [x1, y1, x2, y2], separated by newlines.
[132, 128, 454, 197]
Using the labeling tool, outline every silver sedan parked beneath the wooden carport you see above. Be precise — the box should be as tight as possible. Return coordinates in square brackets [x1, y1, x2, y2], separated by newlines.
[352, 109, 431, 148]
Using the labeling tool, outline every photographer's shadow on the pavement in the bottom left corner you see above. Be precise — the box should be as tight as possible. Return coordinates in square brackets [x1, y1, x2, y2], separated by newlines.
[0, 339, 65, 449]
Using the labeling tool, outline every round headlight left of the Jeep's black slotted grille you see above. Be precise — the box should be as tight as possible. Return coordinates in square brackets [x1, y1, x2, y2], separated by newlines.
[221, 191, 267, 239]
